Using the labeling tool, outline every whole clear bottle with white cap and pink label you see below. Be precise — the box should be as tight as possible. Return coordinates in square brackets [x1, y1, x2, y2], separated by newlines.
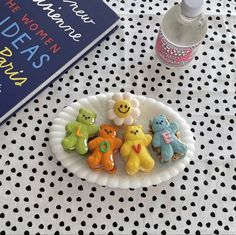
[156, 0, 207, 67]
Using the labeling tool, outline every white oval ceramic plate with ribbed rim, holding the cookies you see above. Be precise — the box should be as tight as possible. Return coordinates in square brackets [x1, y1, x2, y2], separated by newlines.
[50, 93, 194, 188]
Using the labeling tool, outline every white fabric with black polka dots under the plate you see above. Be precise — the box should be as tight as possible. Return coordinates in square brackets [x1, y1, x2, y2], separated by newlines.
[0, 0, 236, 234]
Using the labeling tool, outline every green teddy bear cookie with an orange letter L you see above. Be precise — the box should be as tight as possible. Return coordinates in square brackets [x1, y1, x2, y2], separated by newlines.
[61, 108, 99, 155]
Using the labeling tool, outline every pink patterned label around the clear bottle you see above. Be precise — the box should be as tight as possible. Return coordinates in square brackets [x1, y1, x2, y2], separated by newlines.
[156, 29, 199, 66]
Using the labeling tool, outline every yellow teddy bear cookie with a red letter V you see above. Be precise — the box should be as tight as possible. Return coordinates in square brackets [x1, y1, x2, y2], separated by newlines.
[120, 125, 155, 175]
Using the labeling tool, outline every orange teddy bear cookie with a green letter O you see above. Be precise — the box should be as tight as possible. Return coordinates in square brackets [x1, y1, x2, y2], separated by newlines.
[87, 124, 122, 174]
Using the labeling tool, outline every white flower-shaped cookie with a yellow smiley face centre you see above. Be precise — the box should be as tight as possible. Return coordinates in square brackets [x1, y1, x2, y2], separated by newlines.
[107, 93, 140, 126]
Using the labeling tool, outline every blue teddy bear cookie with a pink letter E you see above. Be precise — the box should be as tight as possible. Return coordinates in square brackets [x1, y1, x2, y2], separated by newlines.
[150, 115, 187, 162]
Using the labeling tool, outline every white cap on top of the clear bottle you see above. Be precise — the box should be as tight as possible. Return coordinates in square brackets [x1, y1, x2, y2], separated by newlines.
[181, 0, 204, 18]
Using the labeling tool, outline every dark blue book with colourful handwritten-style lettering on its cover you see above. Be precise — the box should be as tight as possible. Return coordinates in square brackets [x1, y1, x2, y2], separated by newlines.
[0, 0, 119, 125]
